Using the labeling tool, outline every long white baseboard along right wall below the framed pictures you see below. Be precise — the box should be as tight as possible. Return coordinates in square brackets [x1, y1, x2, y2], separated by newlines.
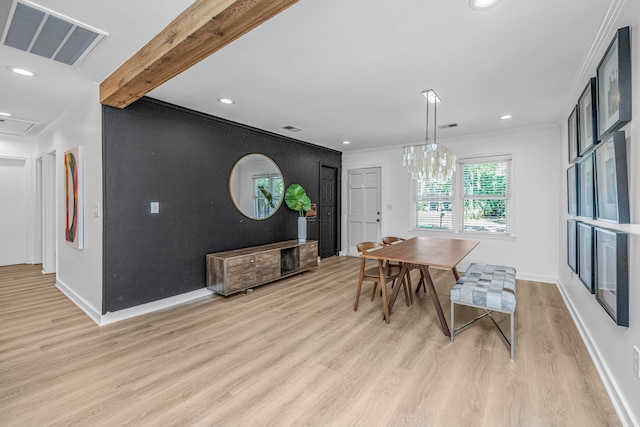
[556, 280, 640, 427]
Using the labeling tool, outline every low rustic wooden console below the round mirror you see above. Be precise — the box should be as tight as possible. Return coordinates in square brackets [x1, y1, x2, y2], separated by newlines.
[207, 240, 318, 295]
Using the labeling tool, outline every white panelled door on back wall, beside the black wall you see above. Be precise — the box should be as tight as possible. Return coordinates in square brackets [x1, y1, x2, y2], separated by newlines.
[347, 167, 382, 255]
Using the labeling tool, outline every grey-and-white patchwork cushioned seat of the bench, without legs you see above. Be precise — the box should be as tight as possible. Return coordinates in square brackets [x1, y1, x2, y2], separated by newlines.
[451, 263, 516, 313]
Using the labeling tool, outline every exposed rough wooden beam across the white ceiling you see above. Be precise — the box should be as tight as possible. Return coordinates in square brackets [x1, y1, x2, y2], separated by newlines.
[100, 0, 298, 108]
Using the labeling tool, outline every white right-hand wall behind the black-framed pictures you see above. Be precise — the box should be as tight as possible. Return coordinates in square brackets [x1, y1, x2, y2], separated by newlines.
[557, 1, 640, 425]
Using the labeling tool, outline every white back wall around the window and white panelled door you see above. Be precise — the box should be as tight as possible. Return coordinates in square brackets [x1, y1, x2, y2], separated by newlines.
[342, 125, 561, 283]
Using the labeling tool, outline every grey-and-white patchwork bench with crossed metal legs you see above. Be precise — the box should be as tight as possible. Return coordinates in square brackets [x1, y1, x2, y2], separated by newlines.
[451, 263, 516, 359]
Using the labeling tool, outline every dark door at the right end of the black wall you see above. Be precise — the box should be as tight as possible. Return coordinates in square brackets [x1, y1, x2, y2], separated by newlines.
[318, 165, 338, 258]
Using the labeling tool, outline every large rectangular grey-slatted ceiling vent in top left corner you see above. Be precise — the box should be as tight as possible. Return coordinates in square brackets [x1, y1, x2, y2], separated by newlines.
[0, 0, 107, 66]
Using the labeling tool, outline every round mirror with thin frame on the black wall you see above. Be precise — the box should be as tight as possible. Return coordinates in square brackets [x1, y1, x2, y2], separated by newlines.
[229, 154, 284, 219]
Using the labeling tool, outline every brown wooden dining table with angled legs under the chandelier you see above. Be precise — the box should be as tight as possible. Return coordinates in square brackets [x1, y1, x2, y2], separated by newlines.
[360, 236, 480, 336]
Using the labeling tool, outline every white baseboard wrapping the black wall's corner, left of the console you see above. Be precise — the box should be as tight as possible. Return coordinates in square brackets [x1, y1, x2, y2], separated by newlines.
[56, 280, 214, 326]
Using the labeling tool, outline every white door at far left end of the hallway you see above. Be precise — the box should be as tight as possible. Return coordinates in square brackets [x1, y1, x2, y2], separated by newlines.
[0, 158, 27, 265]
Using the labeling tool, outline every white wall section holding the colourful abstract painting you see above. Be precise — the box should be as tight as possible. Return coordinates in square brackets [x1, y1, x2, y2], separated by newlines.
[36, 86, 102, 323]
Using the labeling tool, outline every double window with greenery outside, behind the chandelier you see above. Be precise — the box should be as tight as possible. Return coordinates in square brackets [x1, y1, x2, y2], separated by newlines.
[412, 156, 511, 234]
